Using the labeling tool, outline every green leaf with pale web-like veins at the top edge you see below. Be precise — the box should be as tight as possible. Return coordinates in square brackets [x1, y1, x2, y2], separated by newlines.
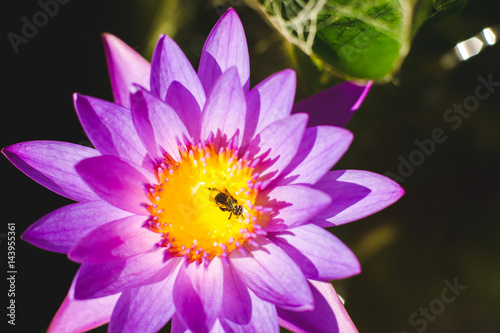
[250, 0, 464, 81]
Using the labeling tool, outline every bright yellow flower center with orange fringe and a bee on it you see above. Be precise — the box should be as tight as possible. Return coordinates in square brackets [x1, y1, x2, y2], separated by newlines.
[148, 137, 270, 263]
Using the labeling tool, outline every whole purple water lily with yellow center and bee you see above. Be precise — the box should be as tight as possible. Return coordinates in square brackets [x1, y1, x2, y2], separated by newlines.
[3, 9, 403, 333]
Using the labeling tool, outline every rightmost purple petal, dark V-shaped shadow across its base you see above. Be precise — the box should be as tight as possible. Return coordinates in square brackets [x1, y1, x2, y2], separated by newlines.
[311, 170, 404, 227]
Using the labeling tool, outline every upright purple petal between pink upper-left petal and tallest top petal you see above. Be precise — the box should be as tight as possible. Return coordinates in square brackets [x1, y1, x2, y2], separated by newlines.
[151, 35, 206, 109]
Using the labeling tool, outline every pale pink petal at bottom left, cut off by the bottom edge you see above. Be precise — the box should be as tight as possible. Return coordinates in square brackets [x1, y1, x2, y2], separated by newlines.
[47, 276, 120, 333]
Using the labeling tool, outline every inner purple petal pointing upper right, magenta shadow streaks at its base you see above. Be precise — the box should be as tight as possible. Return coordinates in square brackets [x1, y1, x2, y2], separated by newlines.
[246, 114, 307, 181]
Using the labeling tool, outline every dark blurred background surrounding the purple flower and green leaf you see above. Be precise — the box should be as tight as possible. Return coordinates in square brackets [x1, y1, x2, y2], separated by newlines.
[0, 0, 500, 333]
